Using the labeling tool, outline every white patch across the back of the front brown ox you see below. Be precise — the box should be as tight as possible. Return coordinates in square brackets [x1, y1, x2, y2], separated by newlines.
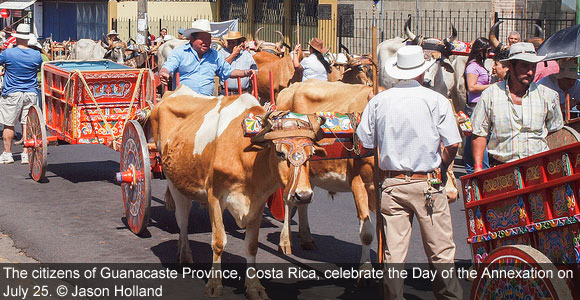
[193, 94, 260, 156]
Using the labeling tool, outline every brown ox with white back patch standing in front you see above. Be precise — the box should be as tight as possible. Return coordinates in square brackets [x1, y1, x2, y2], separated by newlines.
[151, 85, 323, 299]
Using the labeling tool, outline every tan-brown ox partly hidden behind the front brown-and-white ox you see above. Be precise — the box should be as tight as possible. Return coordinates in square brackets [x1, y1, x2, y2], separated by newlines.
[277, 79, 374, 274]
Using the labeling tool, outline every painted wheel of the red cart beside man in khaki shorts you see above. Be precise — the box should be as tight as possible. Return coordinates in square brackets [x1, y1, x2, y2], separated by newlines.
[24, 105, 48, 182]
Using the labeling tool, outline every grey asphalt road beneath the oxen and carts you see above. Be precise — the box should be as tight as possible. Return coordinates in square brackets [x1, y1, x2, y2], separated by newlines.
[0, 129, 471, 299]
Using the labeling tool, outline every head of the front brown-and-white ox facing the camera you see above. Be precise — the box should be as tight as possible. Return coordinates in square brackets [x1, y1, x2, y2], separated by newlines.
[252, 112, 326, 205]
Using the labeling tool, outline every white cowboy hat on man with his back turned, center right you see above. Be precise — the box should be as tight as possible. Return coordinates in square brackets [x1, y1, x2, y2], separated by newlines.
[385, 45, 435, 79]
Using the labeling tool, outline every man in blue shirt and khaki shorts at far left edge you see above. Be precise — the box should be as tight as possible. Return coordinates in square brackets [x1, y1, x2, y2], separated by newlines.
[0, 24, 42, 164]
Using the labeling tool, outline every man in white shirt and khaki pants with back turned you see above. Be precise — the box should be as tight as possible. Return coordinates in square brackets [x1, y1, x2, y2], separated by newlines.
[356, 46, 463, 299]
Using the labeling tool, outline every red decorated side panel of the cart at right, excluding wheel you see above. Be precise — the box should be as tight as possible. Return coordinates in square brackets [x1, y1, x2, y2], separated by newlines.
[461, 143, 580, 299]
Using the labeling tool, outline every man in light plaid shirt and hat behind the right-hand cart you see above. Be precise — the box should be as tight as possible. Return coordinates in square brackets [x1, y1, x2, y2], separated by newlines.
[471, 42, 564, 172]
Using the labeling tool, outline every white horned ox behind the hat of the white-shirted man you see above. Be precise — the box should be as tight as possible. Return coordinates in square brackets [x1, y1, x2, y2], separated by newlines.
[377, 16, 457, 96]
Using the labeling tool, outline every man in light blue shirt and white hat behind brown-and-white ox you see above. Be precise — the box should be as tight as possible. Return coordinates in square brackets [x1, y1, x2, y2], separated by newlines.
[159, 20, 254, 96]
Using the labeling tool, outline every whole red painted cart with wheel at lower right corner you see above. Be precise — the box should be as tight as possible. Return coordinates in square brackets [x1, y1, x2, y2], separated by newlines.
[461, 143, 580, 299]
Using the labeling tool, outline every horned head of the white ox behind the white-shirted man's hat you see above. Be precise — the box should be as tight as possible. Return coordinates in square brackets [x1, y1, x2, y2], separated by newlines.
[405, 15, 457, 88]
